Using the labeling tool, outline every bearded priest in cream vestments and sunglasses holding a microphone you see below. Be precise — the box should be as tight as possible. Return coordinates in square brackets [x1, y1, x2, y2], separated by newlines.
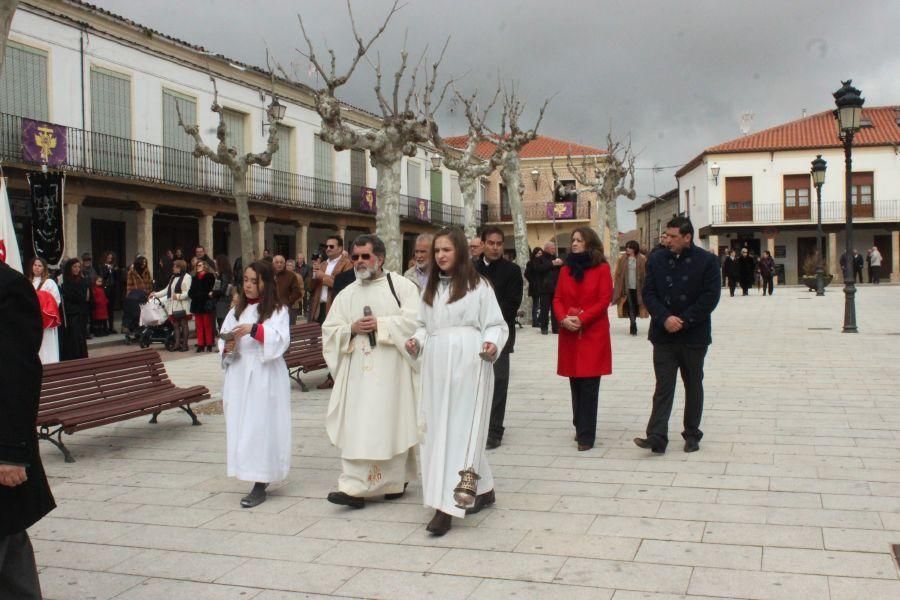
[322, 235, 419, 508]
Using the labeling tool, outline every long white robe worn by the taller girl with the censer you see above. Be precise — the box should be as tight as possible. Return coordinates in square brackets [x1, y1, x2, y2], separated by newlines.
[415, 277, 509, 517]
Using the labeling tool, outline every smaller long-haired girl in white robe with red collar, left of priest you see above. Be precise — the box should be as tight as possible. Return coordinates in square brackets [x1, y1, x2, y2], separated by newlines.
[219, 261, 291, 508]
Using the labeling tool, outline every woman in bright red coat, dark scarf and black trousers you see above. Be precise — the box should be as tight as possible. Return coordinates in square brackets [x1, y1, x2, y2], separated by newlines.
[553, 227, 613, 450]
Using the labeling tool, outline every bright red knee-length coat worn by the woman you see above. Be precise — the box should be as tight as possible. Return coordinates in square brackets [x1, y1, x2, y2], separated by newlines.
[553, 263, 612, 377]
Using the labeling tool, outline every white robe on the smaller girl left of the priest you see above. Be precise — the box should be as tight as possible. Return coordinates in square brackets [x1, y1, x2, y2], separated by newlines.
[219, 304, 291, 483]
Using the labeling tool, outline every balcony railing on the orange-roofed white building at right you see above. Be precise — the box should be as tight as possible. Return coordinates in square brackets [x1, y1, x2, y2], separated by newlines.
[711, 204, 900, 225]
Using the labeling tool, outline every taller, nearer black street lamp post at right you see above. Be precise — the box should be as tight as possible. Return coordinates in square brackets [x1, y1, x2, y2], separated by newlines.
[833, 79, 865, 333]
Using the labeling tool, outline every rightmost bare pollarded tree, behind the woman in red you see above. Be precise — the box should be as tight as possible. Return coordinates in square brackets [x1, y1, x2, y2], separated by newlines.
[566, 131, 636, 253]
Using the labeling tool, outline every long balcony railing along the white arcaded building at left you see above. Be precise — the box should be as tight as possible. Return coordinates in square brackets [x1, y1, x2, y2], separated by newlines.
[0, 113, 463, 226]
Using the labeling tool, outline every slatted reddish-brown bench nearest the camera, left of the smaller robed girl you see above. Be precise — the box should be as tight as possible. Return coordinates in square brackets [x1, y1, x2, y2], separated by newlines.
[37, 349, 209, 462]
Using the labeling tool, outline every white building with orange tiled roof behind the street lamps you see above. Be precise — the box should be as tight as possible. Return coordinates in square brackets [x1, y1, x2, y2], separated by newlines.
[676, 107, 900, 284]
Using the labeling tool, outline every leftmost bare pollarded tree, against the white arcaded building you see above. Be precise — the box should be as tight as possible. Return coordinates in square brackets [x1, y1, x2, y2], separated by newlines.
[175, 76, 278, 266]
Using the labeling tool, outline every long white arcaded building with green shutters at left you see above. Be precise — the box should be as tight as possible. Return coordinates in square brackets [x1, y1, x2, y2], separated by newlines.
[0, 0, 478, 266]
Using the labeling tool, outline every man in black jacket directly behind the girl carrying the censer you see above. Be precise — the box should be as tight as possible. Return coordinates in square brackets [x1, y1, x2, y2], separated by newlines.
[475, 226, 524, 450]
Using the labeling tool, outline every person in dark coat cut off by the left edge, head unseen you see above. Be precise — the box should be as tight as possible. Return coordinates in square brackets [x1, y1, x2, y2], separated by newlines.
[0, 262, 56, 600]
